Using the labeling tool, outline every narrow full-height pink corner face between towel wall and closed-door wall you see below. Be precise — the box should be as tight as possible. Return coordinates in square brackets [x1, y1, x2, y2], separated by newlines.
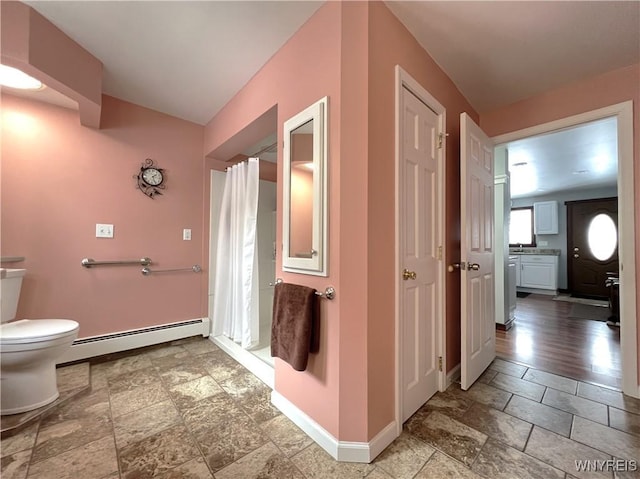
[336, 2, 370, 441]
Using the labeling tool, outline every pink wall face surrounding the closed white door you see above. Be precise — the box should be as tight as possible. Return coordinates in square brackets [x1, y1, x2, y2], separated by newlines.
[368, 2, 478, 430]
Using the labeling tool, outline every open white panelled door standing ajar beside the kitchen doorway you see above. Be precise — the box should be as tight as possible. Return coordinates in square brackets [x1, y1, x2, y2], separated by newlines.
[460, 113, 496, 389]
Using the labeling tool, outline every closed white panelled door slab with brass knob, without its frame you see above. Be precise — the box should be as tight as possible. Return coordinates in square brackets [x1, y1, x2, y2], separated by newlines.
[398, 87, 440, 422]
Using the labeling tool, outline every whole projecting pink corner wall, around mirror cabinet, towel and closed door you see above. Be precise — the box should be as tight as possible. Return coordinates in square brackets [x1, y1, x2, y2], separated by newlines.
[204, 2, 478, 441]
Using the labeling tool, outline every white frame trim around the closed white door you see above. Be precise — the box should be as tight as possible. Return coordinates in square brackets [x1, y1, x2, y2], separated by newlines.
[394, 65, 448, 435]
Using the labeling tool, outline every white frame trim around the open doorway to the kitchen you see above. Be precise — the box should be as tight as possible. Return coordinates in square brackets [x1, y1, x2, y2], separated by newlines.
[492, 101, 640, 398]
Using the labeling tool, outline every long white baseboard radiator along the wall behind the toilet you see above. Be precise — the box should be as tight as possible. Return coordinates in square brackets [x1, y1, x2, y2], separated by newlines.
[57, 318, 210, 364]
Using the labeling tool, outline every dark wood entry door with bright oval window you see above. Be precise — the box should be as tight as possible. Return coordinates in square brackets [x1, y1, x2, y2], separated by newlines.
[565, 198, 618, 298]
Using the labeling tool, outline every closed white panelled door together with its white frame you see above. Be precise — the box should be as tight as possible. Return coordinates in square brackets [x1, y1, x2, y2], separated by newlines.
[395, 66, 446, 434]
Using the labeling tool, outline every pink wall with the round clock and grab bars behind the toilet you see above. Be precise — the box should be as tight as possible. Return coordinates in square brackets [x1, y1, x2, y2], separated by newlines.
[1, 95, 207, 337]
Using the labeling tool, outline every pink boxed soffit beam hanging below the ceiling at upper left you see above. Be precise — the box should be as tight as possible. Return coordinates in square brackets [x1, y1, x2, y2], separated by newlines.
[0, 1, 102, 128]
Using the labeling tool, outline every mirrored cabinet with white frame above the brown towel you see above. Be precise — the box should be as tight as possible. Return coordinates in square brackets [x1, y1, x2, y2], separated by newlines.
[282, 97, 328, 276]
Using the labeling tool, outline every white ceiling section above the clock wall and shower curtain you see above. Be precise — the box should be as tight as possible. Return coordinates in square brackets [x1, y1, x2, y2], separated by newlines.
[24, 1, 323, 125]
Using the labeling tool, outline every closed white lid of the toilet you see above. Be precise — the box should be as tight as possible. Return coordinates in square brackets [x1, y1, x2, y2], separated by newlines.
[0, 319, 78, 344]
